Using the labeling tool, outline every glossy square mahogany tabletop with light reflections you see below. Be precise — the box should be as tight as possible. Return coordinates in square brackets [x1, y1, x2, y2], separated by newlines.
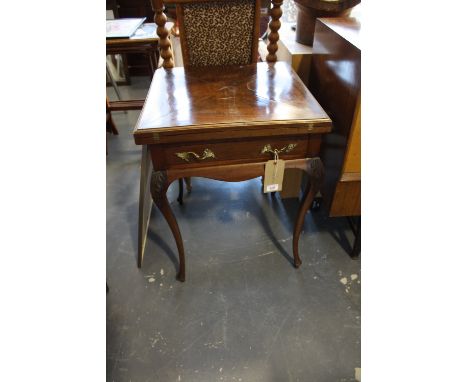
[134, 62, 331, 135]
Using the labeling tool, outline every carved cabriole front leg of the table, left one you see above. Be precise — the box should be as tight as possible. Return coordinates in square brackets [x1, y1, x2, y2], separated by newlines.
[150, 171, 185, 281]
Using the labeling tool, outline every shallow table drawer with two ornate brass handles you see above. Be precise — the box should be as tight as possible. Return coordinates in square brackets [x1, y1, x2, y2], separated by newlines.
[156, 135, 309, 168]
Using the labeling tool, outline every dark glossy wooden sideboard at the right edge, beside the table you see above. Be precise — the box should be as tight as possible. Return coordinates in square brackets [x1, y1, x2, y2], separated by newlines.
[309, 6, 361, 216]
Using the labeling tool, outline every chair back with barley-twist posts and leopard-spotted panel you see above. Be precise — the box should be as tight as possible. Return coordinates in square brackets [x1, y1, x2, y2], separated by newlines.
[151, 0, 283, 68]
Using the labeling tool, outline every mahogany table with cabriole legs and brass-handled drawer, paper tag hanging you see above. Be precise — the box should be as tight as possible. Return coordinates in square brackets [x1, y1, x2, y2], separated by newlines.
[134, 62, 332, 281]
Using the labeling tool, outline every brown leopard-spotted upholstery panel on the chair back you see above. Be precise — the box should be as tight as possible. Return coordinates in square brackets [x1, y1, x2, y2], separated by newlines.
[182, 0, 255, 66]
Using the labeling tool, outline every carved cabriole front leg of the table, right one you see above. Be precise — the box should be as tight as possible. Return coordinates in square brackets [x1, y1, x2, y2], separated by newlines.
[293, 158, 324, 268]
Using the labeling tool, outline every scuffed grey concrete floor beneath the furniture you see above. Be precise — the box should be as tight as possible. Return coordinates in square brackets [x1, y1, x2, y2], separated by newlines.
[107, 78, 361, 382]
